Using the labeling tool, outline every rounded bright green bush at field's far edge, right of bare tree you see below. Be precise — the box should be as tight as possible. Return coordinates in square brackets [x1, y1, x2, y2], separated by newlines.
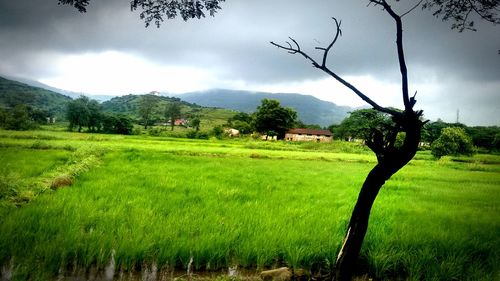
[431, 127, 474, 158]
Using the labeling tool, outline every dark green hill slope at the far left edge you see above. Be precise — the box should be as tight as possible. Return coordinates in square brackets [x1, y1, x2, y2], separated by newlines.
[0, 77, 71, 118]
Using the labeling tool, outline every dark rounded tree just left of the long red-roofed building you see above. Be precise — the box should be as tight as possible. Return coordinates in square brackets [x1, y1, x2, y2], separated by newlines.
[254, 99, 297, 139]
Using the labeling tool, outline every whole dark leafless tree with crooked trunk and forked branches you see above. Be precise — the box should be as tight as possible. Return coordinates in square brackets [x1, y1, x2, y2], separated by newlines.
[271, 0, 425, 280]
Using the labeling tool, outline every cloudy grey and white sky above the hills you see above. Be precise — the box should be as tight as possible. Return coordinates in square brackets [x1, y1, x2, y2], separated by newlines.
[0, 0, 500, 125]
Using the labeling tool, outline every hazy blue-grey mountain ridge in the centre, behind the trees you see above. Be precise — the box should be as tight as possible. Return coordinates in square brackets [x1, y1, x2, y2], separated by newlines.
[177, 89, 353, 127]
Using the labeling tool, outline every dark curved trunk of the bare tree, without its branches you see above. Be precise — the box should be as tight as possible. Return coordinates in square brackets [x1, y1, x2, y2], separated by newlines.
[334, 111, 423, 281]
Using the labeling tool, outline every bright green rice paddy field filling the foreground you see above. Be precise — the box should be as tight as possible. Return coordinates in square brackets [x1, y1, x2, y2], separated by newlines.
[0, 128, 500, 280]
